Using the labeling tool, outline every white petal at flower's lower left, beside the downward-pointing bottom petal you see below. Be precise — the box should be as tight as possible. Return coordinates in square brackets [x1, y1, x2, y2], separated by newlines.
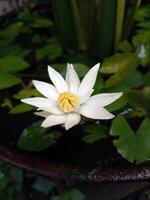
[41, 115, 66, 128]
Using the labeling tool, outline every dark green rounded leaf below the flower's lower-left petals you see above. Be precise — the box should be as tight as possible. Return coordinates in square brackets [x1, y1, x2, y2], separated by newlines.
[18, 122, 55, 151]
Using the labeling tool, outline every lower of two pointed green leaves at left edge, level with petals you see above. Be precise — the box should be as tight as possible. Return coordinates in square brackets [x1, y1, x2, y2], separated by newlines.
[0, 73, 22, 90]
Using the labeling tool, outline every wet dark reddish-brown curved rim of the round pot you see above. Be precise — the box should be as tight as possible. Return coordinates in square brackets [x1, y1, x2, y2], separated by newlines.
[0, 144, 150, 186]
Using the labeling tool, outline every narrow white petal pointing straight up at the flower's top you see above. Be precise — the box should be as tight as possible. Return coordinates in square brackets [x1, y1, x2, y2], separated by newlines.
[66, 63, 80, 94]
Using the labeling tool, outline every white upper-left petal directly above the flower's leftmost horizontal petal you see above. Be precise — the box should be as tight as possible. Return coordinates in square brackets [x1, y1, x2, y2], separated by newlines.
[33, 80, 59, 100]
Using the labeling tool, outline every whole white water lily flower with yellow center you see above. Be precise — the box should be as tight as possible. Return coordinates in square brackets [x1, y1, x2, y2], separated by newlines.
[21, 63, 122, 130]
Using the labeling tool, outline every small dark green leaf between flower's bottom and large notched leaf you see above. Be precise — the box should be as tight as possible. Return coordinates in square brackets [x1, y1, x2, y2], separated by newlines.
[82, 124, 108, 143]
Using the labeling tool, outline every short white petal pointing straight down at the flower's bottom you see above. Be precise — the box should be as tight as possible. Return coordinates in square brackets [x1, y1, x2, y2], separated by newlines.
[65, 113, 81, 130]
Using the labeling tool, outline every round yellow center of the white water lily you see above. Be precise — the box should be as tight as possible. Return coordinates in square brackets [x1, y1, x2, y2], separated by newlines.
[58, 92, 79, 113]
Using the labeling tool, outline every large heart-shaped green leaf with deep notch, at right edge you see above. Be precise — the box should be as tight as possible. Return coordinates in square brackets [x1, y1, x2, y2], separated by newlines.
[110, 116, 150, 163]
